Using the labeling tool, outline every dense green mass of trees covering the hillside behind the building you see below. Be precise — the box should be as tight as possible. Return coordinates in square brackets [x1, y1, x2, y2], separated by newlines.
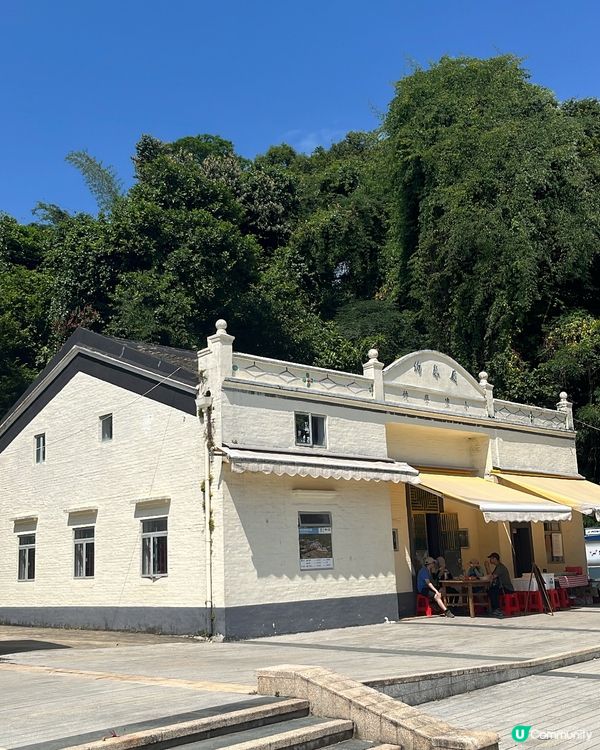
[0, 56, 600, 479]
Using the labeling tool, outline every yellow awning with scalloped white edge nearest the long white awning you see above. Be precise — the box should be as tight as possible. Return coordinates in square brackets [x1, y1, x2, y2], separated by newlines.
[419, 472, 571, 522]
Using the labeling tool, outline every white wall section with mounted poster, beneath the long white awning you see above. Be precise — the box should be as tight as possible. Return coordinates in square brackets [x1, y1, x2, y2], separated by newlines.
[223, 468, 396, 607]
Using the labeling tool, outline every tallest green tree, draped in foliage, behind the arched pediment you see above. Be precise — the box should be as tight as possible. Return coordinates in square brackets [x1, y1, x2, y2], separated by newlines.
[385, 56, 600, 368]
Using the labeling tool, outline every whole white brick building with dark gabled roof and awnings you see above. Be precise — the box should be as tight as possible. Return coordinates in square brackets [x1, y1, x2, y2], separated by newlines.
[0, 321, 600, 637]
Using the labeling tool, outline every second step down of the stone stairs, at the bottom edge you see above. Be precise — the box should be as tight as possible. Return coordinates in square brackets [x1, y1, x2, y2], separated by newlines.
[169, 716, 356, 750]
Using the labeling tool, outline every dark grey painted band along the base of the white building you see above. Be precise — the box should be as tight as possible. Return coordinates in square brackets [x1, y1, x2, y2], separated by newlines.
[0, 594, 404, 638]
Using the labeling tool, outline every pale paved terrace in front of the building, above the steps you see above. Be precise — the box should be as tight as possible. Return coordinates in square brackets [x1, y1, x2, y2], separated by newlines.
[0, 608, 600, 748]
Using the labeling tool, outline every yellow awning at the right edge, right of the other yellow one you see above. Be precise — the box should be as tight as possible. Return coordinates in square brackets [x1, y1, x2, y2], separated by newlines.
[494, 471, 600, 520]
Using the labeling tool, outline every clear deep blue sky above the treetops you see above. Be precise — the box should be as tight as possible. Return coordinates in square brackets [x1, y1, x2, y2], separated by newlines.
[0, 0, 600, 221]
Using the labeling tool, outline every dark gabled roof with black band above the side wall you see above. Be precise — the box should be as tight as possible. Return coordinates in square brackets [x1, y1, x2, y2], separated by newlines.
[0, 328, 199, 451]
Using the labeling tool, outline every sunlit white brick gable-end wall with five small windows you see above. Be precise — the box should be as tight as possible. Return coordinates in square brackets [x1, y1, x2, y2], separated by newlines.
[0, 373, 206, 607]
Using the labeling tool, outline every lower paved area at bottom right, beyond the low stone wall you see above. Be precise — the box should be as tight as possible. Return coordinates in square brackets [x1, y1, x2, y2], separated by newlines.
[420, 660, 600, 750]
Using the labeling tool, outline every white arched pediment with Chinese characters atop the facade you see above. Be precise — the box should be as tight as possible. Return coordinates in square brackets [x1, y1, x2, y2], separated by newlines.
[383, 349, 485, 401]
